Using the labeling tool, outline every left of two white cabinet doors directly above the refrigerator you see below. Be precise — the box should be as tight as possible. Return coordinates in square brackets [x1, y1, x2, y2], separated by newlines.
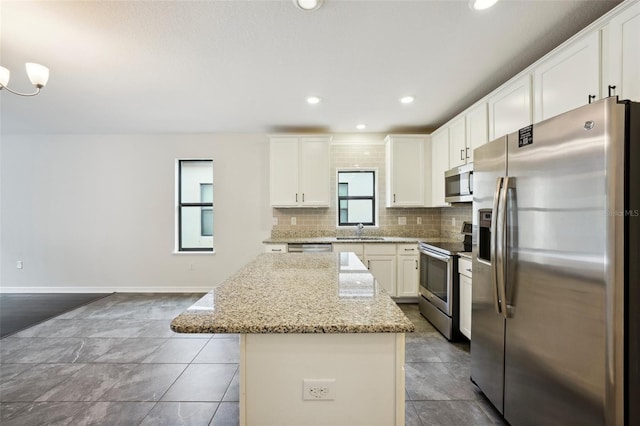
[534, 31, 600, 122]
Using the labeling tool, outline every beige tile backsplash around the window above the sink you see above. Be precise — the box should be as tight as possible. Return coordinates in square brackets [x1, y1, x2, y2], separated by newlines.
[271, 135, 471, 240]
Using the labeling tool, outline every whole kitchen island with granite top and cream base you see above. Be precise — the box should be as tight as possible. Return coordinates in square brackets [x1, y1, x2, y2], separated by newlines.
[171, 253, 414, 425]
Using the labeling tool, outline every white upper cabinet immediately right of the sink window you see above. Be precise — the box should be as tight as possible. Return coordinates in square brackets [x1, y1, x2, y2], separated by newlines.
[385, 135, 426, 207]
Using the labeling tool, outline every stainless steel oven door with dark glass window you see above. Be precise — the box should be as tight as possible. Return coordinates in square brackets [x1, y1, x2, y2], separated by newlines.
[420, 248, 453, 317]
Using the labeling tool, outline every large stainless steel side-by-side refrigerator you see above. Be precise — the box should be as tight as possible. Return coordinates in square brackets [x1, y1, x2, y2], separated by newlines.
[471, 98, 640, 426]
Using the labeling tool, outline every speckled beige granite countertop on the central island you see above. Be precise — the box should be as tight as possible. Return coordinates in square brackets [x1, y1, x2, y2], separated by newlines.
[171, 253, 414, 334]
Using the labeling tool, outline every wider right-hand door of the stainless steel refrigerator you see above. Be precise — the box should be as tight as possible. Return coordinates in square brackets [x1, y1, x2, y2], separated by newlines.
[500, 102, 622, 425]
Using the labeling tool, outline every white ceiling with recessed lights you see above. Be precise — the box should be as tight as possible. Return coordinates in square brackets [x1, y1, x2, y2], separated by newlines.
[0, 0, 619, 134]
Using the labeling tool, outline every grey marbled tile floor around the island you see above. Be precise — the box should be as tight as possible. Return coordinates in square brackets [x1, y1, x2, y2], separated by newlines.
[0, 293, 504, 426]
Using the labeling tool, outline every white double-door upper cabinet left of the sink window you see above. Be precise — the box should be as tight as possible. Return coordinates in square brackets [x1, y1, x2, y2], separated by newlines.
[269, 136, 331, 207]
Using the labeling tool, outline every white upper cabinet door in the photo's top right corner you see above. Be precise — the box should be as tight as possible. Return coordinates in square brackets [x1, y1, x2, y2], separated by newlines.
[602, 2, 640, 102]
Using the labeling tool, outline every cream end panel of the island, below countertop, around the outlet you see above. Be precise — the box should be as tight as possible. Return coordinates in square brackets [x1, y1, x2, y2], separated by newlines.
[240, 333, 405, 426]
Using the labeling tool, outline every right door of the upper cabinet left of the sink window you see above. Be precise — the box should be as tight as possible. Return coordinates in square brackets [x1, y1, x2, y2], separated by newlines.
[298, 138, 330, 207]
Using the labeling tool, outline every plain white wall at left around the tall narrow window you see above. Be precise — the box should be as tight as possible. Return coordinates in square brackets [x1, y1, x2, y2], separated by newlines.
[0, 134, 271, 292]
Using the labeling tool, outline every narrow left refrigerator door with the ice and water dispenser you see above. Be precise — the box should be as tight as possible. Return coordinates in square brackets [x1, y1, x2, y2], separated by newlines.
[471, 137, 507, 412]
